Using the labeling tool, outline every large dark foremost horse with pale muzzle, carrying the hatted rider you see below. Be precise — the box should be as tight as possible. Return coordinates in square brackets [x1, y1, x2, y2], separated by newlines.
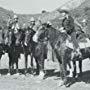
[36, 23, 90, 86]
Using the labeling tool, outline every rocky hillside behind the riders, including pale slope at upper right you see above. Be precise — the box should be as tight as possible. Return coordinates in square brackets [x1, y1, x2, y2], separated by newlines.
[0, 0, 90, 27]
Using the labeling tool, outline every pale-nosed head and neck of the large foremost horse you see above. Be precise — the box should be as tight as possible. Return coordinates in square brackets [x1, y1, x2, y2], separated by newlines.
[33, 23, 68, 47]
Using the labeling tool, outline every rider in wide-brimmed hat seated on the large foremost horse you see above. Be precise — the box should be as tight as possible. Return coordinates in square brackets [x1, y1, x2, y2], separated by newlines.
[60, 10, 81, 57]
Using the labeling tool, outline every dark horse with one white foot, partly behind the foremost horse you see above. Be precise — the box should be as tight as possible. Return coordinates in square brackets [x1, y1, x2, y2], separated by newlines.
[25, 29, 47, 78]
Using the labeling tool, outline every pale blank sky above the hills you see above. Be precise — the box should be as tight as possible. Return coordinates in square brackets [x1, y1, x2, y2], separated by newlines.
[0, 0, 70, 14]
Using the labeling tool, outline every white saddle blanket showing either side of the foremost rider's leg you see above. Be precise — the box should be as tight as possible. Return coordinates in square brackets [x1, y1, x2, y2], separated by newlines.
[66, 38, 90, 49]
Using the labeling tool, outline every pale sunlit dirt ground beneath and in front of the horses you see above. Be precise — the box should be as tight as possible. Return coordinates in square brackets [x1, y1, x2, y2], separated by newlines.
[0, 54, 90, 90]
